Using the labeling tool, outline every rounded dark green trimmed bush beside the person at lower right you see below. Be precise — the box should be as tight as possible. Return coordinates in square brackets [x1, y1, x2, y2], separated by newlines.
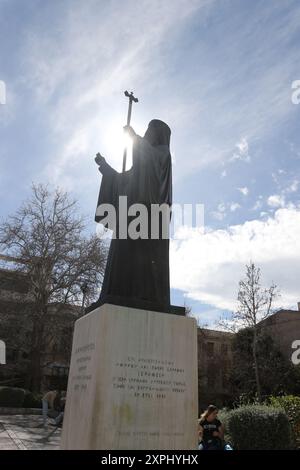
[225, 405, 292, 450]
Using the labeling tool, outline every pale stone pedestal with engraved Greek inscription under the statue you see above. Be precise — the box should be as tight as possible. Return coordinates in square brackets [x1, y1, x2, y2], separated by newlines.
[61, 304, 198, 450]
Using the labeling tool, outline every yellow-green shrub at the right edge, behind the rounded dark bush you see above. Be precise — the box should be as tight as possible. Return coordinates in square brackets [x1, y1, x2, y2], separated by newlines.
[268, 395, 300, 448]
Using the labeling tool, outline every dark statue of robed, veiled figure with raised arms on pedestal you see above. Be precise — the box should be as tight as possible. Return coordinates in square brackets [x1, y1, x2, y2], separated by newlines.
[95, 119, 172, 312]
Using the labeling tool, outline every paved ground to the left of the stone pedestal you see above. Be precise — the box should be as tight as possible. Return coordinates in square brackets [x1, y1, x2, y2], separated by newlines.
[0, 415, 61, 450]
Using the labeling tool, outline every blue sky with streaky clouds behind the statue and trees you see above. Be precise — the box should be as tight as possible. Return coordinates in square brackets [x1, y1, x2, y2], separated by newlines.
[0, 0, 300, 324]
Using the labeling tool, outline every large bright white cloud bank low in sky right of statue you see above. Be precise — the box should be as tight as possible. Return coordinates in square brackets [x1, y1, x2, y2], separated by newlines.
[170, 208, 300, 310]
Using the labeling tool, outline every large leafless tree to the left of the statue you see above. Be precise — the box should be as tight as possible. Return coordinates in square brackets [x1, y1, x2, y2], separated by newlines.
[0, 184, 107, 388]
